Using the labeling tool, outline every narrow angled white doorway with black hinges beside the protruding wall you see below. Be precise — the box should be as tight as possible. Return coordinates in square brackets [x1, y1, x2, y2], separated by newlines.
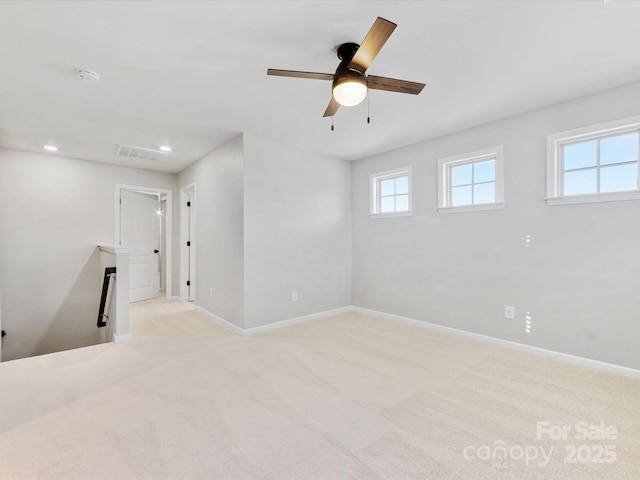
[180, 183, 196, 302]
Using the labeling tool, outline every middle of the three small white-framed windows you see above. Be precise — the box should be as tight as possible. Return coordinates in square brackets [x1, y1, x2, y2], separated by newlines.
[438, 147, 504, 213]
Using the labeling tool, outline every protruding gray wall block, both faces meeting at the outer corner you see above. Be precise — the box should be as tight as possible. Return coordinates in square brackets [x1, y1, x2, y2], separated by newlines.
[179, 133, 351, 329]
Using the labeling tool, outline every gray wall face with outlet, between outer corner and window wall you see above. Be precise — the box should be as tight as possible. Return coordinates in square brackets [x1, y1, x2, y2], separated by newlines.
[244, 134, 351, 328]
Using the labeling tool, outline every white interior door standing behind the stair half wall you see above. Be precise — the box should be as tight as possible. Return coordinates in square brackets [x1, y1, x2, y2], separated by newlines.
[120, 190, 160, 302]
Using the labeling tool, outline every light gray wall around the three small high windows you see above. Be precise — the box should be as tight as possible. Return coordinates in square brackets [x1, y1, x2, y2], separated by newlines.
[352, 83, 640, 368]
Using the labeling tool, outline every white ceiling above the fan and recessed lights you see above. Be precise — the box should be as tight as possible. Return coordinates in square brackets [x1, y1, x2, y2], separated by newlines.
[0, 0, 640, 172]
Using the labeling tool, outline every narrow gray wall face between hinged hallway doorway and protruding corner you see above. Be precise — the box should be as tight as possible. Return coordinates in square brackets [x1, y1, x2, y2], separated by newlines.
[176, 135, 244, 328]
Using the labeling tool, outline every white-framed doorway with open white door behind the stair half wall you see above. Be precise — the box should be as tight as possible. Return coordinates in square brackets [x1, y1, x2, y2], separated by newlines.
[115, 185, 172, 302]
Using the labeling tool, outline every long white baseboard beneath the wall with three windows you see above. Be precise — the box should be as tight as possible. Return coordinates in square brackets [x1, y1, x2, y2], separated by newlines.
[351, 306, 640, 379]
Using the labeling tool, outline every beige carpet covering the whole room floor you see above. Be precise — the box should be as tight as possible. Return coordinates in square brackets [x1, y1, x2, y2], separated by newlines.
[0, 300, 640, 480]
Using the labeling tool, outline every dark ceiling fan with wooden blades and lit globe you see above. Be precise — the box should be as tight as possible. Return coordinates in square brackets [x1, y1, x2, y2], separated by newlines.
[267, 17, 425, 117]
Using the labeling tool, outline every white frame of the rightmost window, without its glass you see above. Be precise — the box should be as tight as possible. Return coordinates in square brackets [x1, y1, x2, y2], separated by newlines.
[545, 115, 640, 206]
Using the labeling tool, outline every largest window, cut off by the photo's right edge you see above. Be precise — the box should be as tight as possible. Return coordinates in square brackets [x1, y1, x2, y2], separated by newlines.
[547, 117, 640, 205]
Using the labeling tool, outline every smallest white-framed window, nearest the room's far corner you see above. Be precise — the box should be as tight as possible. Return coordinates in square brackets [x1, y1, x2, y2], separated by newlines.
[370, 167, 411, 217]
